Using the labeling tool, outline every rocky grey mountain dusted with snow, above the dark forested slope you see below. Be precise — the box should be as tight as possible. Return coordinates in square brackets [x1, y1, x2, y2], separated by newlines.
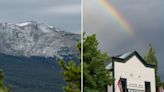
[0, 21, 80, 58]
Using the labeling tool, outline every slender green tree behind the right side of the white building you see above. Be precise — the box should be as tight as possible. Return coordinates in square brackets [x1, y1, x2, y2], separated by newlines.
[145, 44, 161, 88]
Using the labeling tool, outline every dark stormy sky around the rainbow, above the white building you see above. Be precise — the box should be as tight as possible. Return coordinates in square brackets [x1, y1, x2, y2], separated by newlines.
[84, 0, 164, 80]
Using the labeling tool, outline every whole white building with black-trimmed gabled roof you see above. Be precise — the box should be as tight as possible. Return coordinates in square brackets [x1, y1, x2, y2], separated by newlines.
[106, 51, 156, 92]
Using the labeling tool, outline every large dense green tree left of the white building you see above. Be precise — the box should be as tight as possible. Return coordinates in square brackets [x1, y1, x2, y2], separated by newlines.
[83, 35, 113, 92]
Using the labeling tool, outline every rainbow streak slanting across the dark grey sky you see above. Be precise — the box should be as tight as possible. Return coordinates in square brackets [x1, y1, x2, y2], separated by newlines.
[100, 0, 133, 34]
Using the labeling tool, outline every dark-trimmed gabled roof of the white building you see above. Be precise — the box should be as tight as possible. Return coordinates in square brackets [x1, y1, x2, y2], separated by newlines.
[106, 51, 155, 70]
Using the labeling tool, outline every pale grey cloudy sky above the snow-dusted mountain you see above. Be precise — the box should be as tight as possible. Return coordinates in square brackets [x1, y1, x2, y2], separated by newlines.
[0, 0, 81, 33]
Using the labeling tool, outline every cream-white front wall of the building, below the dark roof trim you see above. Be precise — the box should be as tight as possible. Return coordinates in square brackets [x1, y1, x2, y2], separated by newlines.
[113, 56, 156, 92]
